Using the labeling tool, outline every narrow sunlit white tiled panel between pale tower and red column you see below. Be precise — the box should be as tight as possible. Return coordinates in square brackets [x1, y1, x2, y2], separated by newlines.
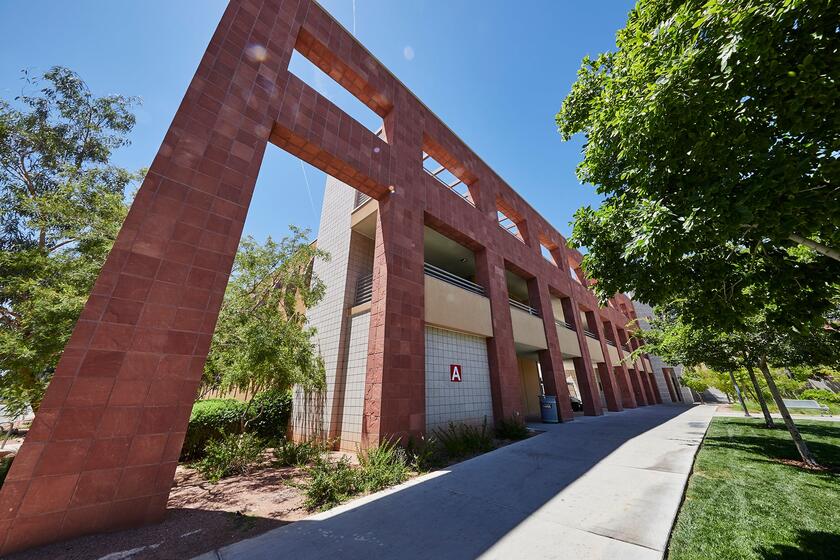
[341, 312, 370, 449]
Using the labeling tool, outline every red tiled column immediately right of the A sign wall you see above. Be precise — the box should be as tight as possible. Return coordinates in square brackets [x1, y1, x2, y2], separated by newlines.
[475, 249, 522, 421]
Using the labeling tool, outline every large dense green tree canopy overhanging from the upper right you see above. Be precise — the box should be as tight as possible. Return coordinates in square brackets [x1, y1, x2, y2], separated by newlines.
[556, 0, 840, 328]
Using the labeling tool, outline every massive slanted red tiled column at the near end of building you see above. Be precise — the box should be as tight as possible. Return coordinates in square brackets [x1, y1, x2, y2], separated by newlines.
[0, 0, 314, 554]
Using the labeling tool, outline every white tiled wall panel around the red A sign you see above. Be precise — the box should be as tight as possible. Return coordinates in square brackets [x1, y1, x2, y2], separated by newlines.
[426, 326, 493, 432]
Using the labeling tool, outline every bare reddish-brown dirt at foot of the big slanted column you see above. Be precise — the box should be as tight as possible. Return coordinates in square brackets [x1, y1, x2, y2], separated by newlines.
[6, 465, 309, 560]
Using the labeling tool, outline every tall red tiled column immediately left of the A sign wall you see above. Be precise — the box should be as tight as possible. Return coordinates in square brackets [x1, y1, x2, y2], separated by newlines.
[362, 97, 426, 444]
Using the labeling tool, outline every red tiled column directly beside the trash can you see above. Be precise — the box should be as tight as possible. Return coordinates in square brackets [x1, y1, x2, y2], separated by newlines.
[528, 278, 575, 422]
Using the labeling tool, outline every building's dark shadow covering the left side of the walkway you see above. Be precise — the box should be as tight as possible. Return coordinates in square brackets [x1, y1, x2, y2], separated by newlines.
[200, 406, 705, 559]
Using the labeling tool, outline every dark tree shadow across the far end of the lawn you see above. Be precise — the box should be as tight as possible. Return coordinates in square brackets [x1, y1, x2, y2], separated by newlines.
[705, 422, 840, 474]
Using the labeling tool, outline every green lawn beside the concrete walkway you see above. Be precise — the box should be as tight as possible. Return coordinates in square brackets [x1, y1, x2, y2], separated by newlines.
[668, 418, 840, 560]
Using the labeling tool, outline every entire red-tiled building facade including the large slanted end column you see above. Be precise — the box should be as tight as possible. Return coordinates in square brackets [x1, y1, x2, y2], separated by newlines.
[0, 0, 688, 555]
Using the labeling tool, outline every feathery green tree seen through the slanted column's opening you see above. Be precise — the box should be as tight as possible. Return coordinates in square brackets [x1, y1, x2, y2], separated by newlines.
[205, 226, 328, 424]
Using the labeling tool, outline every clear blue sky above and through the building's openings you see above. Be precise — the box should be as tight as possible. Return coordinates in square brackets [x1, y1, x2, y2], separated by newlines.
[0, 0, 633, 244]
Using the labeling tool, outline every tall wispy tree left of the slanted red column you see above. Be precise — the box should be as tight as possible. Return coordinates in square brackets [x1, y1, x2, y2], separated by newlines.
[0, 67, 139, 413]
